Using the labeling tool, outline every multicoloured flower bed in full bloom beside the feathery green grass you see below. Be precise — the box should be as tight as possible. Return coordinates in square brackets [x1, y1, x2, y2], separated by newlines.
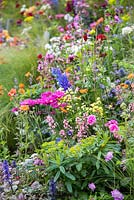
[0, 0, 134, 200]
